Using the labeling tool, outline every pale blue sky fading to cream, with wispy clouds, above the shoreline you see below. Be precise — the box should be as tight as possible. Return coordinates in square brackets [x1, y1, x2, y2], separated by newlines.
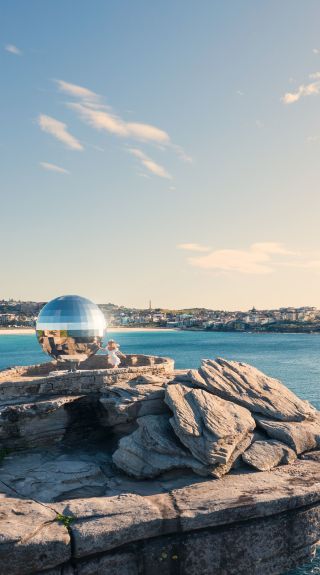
[0, 0, 320, 310]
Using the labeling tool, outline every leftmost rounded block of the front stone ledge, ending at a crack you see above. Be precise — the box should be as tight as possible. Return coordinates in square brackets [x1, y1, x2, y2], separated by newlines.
[0, 499, 71, 575]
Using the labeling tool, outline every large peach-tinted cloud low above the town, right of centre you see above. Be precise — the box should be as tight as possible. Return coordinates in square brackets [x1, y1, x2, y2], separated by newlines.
[185, 242, 294, 275]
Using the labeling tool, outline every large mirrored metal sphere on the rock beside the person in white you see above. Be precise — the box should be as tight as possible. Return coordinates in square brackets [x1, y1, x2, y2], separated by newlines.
[36, 295, 106, 363]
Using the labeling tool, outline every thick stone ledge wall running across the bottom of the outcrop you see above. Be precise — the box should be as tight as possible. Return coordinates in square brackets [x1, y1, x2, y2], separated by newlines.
[0, 461, 320, 575]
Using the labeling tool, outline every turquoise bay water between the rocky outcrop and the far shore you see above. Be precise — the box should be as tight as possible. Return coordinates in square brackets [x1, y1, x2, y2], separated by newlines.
[0, 331, 320, 575]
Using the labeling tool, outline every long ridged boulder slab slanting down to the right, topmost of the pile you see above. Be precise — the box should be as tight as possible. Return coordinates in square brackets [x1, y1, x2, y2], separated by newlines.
[199, 358, 317, 421]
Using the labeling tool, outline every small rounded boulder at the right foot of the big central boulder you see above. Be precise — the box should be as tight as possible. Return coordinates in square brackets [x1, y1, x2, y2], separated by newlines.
[242, 440, 297, 471]
